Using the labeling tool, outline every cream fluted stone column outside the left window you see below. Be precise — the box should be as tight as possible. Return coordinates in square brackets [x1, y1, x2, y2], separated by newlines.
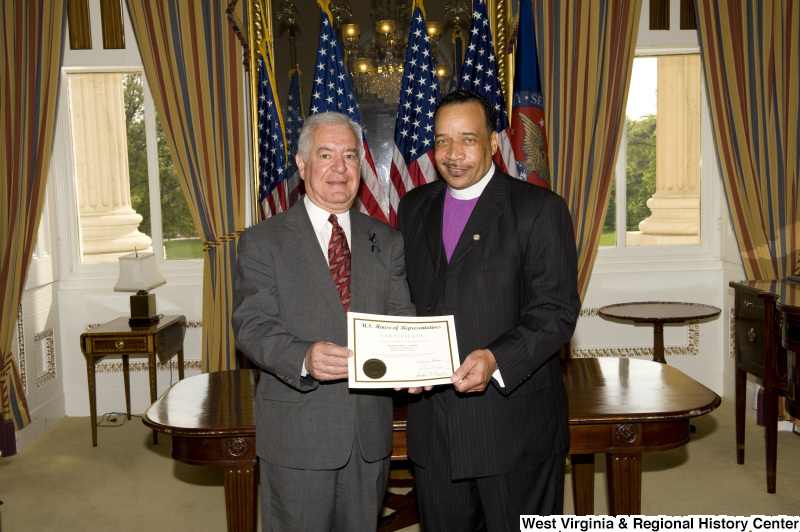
[69, 74, 152, 262]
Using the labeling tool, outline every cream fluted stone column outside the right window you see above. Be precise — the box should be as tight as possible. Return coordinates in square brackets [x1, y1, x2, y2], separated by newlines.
[627, 55, 701, 245]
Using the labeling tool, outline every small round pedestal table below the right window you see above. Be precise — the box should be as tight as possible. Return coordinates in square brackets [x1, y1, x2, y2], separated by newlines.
[597, 301, 720, 364]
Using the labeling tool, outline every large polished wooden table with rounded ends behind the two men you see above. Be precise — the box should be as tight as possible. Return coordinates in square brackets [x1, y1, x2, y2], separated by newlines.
[143, 358, 720, 531]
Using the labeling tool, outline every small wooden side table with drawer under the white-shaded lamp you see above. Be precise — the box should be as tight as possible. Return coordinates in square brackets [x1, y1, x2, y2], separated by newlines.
[81, 316, 186, 447]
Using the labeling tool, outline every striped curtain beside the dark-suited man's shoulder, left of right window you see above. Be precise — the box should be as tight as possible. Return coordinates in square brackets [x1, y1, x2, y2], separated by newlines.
[523, 0, 642, 298]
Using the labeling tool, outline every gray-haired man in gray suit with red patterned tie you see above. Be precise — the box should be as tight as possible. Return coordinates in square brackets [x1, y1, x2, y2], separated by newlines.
[232, 113, 414, 532]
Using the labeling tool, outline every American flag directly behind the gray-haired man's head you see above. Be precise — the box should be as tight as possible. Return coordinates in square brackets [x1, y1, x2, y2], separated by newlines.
[309, 0, 394, 223]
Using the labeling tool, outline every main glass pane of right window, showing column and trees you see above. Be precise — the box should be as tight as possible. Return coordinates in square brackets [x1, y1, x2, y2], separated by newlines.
[600, 54, 701, 247]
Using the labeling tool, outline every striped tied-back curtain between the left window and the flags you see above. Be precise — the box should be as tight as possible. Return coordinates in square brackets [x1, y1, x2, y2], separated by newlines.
[127, 0, 248, 372]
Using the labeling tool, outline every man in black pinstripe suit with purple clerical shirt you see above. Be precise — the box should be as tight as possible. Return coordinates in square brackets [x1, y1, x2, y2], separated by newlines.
[398, 91, 580, 532]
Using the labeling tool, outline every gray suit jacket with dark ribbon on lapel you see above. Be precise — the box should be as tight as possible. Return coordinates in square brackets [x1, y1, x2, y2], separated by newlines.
[232, 201, 414, 469]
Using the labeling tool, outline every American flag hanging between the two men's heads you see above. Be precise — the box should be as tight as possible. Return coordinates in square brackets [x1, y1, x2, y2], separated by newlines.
[389, 5, 439, 225]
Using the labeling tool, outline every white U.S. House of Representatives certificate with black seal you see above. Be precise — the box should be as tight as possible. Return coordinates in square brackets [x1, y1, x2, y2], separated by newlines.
[347, 312, 461, 388]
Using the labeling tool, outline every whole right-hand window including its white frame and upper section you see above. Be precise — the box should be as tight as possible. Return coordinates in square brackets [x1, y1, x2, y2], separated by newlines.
[598, 0, 719, 260]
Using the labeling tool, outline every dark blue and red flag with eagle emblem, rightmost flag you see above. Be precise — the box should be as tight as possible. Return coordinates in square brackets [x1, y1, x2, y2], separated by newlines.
[511, 0, 551, 188]
